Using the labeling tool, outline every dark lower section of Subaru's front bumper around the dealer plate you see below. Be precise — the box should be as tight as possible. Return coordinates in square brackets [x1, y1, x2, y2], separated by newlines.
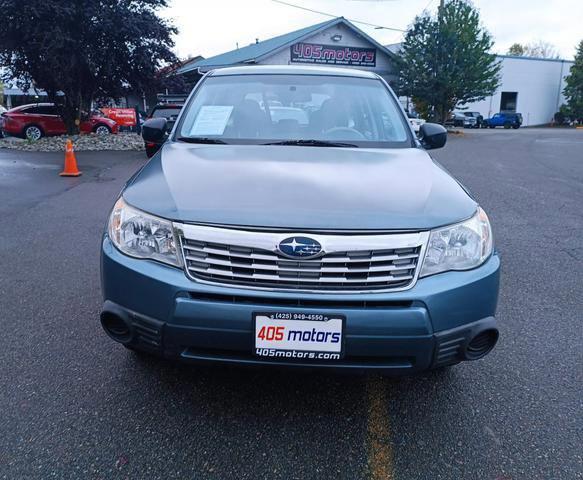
[103, 301, 498, 374]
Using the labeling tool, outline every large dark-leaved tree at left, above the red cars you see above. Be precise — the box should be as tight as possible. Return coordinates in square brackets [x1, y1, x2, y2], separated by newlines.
[0, 0, 177, 134]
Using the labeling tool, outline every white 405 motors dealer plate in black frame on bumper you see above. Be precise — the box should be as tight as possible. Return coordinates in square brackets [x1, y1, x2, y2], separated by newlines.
[253, 312, 346, 361]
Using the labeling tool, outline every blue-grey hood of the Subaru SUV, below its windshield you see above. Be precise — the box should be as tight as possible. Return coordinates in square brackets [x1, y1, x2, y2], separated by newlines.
[123, 142, 476, 230]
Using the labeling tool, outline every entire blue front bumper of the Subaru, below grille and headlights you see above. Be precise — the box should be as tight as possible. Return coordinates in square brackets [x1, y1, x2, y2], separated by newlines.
[101, 236, 500, 373]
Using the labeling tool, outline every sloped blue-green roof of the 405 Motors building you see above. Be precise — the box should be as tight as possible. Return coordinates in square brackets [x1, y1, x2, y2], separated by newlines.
[177, 17, 394, 73]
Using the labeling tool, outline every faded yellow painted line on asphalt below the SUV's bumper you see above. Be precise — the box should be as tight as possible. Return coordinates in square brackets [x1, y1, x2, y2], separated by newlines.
[366, 376, 394, 480]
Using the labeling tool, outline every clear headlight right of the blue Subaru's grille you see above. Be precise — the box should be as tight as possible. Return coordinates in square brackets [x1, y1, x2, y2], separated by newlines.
[420, 208, 492, 277]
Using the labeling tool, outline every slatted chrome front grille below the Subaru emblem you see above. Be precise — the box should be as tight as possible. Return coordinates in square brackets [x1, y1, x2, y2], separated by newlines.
[182, 227, 421, 291]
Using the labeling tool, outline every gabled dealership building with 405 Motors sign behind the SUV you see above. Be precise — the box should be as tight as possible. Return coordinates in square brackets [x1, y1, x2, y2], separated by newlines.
[178, 17, 396, 86]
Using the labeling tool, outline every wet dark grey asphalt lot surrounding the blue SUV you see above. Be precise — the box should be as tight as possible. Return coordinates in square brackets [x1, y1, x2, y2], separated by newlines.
[0, 129, 583, 480]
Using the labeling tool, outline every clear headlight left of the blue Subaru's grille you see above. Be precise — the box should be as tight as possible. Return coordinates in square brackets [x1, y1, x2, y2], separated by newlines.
[108, 198, 180, 266]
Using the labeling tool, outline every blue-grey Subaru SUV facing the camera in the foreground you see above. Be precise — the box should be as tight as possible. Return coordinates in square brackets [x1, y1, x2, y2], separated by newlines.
[101, 65, 500, 373]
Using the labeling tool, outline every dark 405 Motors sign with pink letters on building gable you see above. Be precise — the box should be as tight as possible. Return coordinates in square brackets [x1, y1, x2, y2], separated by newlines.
[290, 43, 377, 67]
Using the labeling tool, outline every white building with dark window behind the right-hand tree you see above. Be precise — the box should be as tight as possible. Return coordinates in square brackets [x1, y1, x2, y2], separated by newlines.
[461, 55, 574, 126]
